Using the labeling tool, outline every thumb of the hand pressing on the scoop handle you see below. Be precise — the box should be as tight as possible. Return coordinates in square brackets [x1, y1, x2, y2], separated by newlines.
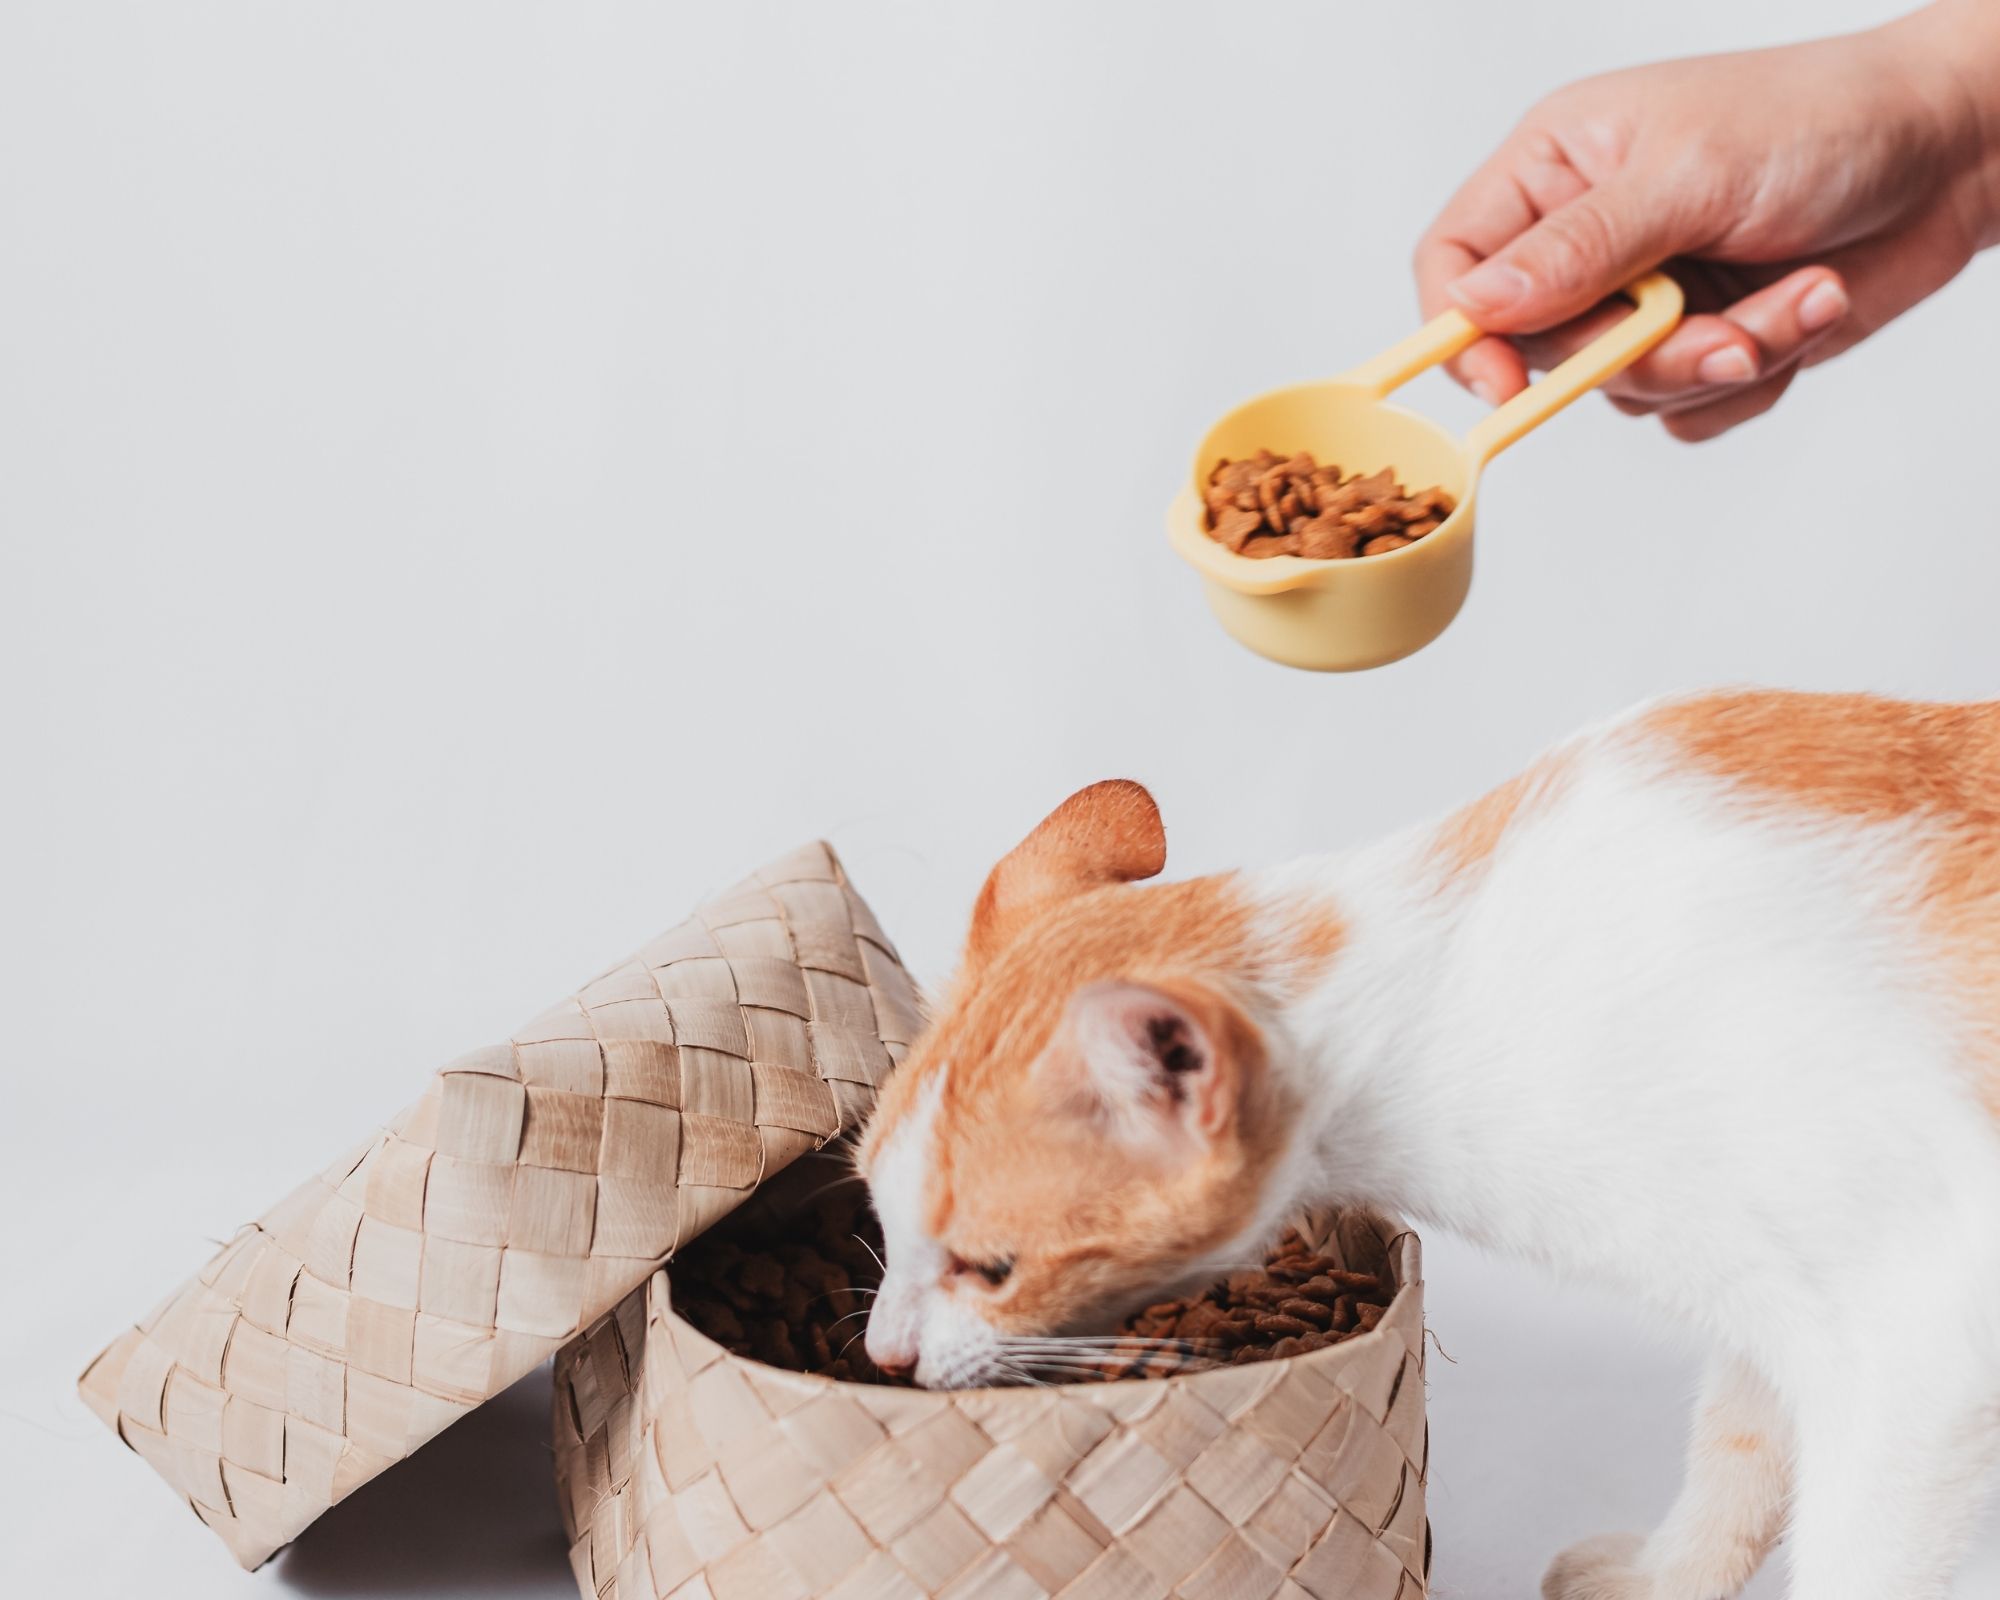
[1446, 176, 1686, 334]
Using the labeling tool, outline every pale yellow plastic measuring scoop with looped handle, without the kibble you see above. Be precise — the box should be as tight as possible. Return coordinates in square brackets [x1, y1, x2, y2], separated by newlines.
[1166, 272, 1680, 672]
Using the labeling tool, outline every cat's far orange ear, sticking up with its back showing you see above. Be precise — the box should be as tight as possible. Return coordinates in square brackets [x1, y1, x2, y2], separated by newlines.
[966, 778, 1166, 962]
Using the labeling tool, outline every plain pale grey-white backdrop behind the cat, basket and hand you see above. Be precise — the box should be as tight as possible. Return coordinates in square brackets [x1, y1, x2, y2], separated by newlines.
[0, 0, 2000, 1600]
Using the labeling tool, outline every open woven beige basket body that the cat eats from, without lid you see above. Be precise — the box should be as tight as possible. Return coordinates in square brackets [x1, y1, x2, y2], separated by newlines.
[554, 1160, 1430, 1600]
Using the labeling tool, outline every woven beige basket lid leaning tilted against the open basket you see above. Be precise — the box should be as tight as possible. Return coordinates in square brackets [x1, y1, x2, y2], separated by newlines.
[80, 844, 918, 1566]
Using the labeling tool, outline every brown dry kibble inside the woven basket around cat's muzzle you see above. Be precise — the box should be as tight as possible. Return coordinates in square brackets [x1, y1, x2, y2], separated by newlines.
[670, 1182, 1394, 1384]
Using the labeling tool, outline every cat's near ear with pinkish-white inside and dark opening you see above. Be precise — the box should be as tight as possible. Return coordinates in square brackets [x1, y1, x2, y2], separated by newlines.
[1060, 982, 1248, 1154]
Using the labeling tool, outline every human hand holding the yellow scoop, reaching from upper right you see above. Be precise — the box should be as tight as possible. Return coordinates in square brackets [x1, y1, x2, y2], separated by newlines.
[1416, 0, 2000, 440]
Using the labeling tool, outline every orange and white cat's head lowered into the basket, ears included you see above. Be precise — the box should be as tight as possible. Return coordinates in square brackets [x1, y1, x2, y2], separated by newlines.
[858, 780, 1294, 1388]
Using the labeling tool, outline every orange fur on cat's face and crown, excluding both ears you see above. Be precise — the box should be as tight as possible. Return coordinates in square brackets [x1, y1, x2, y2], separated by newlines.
[864, 876, 1296, 1332]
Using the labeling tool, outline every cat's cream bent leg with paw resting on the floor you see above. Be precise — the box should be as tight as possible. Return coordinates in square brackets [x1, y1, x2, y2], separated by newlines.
[1542, 1356, 1792, 1600]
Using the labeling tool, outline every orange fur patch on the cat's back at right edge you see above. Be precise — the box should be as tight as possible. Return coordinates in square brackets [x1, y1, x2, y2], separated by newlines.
[1640, 692, 2000, 1120]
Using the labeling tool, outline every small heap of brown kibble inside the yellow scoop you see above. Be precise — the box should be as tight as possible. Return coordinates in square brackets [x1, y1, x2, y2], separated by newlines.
[1202, 450, 1456, 560]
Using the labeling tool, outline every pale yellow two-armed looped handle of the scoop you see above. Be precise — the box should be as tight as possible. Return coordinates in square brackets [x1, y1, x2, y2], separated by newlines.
[1340, 272, 1682, 466]
